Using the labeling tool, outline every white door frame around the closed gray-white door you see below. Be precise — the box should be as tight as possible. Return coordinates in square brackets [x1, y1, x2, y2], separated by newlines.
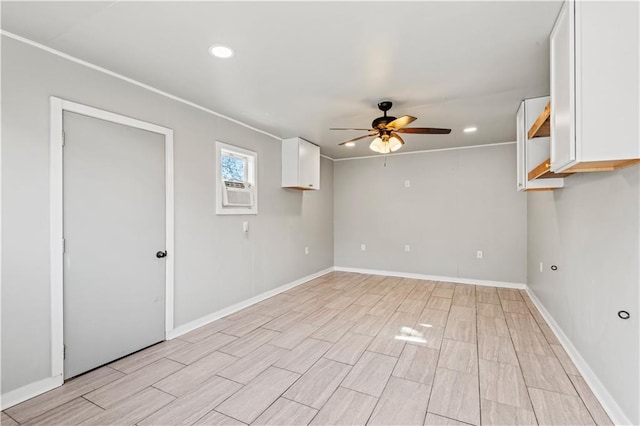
[49, 96, 174, 382]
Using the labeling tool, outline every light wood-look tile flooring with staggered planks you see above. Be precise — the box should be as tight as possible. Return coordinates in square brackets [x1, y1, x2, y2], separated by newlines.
[2, 272, 611, 426]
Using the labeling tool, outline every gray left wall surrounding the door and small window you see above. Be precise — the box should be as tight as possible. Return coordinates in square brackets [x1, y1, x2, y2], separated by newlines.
[2, 37, 333, 393]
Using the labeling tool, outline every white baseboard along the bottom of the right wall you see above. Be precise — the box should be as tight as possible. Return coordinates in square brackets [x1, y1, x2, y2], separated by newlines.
[526, 286, 633, 425]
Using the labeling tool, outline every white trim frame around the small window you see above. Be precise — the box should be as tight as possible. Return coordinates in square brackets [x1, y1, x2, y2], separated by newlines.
[215, 141, 258, 215]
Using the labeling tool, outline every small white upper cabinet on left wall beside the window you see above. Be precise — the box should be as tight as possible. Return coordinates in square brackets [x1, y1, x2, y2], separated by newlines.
[282, 138, 320, 190]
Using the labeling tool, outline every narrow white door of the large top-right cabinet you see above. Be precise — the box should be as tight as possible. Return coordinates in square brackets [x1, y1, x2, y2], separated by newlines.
[550, 1, 576, 172]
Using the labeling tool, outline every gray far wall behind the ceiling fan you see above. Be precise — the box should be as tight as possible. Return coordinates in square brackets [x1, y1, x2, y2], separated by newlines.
[334, 141, 527, 283]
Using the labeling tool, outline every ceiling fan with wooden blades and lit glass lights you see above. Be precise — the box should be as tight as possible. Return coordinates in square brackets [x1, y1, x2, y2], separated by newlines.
[329, 101, 451, 154]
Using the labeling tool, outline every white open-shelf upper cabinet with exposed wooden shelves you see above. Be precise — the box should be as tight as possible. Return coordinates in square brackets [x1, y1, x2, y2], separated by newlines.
[516, 96, 564, 191]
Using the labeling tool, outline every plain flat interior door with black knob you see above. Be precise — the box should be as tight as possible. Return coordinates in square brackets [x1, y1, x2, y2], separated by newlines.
[63, 111, 166, 379]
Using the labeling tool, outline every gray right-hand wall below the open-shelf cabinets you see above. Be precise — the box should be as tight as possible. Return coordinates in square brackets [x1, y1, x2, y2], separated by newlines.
[528, 166, 640, 424]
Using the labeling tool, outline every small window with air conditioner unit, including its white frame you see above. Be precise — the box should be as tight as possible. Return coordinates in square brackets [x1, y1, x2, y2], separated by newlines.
[216, 142, 258, 214]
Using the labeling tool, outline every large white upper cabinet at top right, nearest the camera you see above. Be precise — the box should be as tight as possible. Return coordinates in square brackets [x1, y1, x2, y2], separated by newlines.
[550, 1, 640, 172]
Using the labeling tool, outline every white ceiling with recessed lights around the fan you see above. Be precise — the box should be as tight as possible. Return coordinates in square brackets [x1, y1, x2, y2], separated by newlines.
[2, 1, 561, 158]
